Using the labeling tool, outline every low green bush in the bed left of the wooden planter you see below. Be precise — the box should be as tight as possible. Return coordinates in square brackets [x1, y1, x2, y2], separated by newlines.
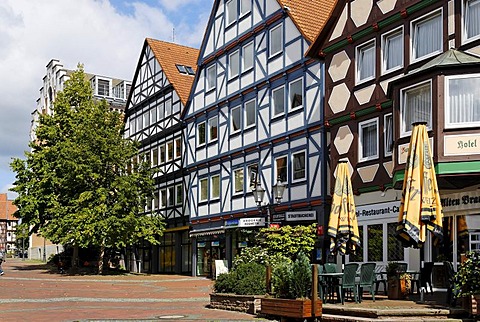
[213, 263, 266, 295]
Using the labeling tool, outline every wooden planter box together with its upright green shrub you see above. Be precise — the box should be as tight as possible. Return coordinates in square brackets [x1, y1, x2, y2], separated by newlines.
[261, 253, 322, 318]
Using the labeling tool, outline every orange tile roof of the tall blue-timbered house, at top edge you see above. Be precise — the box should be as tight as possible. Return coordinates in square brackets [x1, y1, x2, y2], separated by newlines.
[277, 0, 336, 43]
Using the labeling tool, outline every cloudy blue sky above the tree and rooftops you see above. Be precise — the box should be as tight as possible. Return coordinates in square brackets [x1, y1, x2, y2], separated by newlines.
[0, 0, 214, 199]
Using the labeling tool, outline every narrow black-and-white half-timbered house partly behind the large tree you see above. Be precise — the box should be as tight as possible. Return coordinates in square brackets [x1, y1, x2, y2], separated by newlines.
[125, 38, 198, 274]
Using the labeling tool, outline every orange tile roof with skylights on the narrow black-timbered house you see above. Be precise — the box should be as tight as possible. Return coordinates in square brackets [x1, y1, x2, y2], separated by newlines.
[146, 38, 199, 106]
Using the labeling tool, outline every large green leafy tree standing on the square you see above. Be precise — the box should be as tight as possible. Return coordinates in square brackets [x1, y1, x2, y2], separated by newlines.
[11, 65, 164, 273]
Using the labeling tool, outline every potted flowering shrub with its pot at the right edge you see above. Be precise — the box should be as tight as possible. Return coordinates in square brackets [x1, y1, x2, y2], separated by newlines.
[453, 251, 480, 315]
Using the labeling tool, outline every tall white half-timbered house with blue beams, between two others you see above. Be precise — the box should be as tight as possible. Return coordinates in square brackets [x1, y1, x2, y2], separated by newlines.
[184, 0, 332, 275]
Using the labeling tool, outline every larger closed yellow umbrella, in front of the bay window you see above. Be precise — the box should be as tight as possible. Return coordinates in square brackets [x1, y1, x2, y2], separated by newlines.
[397, 124, 443, 248]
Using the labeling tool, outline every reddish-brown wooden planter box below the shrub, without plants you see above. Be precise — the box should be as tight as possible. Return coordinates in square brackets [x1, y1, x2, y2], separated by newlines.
[261, 298, 322, 318]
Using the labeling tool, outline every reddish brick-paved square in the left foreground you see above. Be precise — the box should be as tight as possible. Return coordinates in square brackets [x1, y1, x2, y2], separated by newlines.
[0, 259, 261, 322]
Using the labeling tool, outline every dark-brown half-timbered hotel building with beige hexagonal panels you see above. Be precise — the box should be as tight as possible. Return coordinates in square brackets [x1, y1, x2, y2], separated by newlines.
[308, 0, 480, 277]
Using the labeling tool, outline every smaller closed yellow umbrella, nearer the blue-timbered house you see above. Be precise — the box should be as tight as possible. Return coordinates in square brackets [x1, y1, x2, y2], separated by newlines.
[328, 162, 360, 255]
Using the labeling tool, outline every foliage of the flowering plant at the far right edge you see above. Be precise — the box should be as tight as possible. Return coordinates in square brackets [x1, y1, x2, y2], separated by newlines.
[453, 251, 480, 297]
